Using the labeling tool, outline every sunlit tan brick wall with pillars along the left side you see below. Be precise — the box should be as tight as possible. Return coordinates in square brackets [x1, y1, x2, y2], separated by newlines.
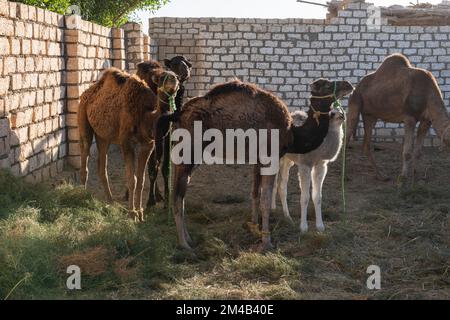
[0, 0, 150, 181]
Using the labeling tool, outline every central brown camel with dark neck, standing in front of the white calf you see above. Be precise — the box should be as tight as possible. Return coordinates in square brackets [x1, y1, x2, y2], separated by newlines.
[161, 79, 353, 249]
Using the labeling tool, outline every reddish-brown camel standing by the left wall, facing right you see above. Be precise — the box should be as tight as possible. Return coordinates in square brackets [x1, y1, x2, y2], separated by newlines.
[78, 68, 178, 221]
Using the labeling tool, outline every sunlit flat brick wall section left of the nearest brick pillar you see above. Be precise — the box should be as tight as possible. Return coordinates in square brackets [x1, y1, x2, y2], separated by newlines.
[0, 1, 67, 181]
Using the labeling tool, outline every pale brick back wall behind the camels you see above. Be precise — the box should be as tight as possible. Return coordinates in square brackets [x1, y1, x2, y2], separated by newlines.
[149, 3, 450, 145]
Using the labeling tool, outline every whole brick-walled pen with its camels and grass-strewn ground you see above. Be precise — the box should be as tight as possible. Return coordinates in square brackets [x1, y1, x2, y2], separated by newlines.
[0, 0, 450, 300]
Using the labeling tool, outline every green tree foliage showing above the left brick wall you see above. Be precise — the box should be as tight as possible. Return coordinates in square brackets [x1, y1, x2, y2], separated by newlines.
[17, 0, 169, 27]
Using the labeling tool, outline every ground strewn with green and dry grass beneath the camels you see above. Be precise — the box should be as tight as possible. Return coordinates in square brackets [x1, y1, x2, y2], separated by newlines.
[0, 145, 450, 300]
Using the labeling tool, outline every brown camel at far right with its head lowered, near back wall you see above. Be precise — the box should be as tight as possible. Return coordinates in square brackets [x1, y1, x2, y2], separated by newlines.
[347, 54, 450, 184]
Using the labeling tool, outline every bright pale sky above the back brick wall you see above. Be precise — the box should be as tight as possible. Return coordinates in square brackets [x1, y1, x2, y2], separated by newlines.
[139, 0, 442, 31]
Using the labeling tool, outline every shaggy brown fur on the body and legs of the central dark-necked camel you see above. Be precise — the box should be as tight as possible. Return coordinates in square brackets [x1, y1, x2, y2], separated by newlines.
[167, 80, 353, 249]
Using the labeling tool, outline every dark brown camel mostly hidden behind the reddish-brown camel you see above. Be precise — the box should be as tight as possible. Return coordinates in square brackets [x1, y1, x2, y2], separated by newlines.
[125, 56, 192, 207]
